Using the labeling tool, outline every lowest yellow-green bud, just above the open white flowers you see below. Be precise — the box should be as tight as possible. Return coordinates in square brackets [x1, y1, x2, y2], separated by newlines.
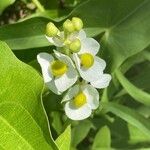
[69, 39, 81, 53]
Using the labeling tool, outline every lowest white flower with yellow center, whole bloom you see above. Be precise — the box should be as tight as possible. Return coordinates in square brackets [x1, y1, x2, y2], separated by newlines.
[62, 84, 99, 120]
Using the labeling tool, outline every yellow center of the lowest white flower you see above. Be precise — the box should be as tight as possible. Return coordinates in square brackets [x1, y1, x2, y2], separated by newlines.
[73, 92, 86, 108]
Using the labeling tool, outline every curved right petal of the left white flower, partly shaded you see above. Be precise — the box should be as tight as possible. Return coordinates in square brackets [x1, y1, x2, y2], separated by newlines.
[54, 51, 78, 92]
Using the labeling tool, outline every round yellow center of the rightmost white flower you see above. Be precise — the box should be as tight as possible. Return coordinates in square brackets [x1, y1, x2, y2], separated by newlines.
[80, 53, 94, 69]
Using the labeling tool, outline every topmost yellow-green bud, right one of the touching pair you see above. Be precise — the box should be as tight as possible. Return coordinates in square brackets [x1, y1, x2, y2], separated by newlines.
[72, 17, 83, 31]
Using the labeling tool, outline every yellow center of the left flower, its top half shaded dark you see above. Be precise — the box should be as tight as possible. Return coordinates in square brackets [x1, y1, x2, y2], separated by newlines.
[50, 60, 68, 76]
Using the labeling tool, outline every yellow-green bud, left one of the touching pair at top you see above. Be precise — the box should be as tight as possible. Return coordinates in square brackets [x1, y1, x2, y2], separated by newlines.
[63, 19, 75, 33]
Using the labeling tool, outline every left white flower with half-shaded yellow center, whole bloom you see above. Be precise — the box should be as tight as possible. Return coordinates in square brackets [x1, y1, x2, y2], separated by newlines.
[37, 51, 78, 94]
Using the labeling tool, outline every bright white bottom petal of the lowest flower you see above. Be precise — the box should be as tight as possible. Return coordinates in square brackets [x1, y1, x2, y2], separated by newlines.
[65, 101, 92, 120]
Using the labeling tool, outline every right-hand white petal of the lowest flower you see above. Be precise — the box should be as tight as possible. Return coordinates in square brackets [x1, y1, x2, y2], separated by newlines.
[81, 84, 99, 109]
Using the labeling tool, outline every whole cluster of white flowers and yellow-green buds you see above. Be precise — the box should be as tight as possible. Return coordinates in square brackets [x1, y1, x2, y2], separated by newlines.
[37, 17, 111, 120]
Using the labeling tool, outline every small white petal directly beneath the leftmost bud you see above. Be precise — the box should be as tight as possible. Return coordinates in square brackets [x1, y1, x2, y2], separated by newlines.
[46, 32, 64, 47]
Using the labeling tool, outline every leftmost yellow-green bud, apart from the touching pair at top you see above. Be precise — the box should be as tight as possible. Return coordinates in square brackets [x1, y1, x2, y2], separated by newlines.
[46, 22, 59, 37]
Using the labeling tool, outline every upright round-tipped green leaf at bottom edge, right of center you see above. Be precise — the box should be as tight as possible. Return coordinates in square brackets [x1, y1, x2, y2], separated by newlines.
[92, 126, 111, 150]
